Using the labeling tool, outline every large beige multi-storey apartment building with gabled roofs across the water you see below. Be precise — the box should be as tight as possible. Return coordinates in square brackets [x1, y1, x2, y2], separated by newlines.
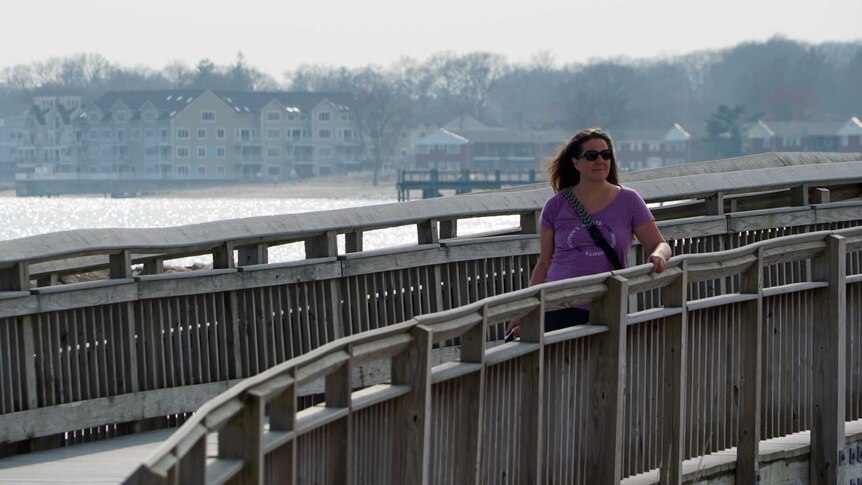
[18, 90, 365, 180]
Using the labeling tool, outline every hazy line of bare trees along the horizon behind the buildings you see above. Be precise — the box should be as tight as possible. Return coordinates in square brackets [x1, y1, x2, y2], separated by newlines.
[0, 37, 862, 178]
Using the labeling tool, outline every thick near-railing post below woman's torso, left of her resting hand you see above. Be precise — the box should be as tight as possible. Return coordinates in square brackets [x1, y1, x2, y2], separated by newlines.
[585, 276, 629, 483]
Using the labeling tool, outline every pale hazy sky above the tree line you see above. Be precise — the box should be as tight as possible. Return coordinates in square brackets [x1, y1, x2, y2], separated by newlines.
[6, 0, 862, 81]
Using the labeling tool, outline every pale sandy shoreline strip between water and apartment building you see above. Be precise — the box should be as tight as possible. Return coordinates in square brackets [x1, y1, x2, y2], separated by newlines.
[0, 173, 398, 201]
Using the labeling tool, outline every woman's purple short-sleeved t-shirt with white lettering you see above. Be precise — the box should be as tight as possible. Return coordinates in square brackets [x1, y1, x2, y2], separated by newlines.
[541, 187, 655, 282]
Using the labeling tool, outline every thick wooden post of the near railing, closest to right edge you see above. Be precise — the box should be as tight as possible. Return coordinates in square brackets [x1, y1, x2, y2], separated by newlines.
[809, 235, 847, 484]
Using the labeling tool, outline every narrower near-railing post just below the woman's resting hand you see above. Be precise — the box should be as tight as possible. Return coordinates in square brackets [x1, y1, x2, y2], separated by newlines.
[660, 261, 688, 485]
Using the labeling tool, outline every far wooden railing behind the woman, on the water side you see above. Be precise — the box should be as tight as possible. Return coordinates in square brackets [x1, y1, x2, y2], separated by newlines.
[0, 149, 862, 466]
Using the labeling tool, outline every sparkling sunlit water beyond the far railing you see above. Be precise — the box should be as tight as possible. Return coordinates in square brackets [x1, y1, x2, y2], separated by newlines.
[0, 197, 518, 266]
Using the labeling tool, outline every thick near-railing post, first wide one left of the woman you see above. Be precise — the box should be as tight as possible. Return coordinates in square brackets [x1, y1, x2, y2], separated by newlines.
[392, 325, 432, 485]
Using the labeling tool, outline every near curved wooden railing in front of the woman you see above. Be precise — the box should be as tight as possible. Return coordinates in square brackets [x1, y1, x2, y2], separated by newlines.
[127, 228, 862, 483]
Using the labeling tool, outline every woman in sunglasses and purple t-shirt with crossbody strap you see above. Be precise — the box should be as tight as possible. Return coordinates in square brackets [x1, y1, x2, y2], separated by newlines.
[508, 128, 671, 336]
